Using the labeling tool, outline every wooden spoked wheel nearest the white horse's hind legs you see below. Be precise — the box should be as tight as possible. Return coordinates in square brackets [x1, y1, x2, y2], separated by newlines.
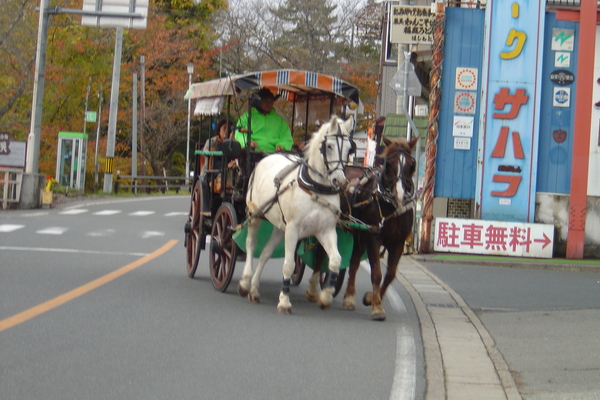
[210, 203, 237, 292]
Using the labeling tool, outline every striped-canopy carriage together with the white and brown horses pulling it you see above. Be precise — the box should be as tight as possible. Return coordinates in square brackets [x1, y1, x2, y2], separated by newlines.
[185, 70, 416, 319]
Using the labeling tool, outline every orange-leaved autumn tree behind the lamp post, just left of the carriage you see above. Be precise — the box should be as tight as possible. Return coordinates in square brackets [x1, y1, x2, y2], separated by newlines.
[126, 0, 226, 174]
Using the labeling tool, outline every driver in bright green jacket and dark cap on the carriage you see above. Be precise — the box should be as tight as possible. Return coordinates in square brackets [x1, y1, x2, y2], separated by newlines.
[235, 88, 294, 153]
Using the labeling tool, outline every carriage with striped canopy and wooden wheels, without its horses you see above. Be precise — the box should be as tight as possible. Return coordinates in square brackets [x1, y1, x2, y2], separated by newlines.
[185, 70, 360, 291]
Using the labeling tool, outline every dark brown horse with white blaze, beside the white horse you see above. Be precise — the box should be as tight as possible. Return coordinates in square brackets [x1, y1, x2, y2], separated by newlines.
[311, 137, 418, 321]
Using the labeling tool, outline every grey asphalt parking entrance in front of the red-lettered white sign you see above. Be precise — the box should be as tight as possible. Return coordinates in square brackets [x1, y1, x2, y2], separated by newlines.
[426, 263, 600, 400]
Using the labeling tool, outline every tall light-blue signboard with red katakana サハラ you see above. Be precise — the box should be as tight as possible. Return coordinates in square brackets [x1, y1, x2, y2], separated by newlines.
[477, 0, 544, 222]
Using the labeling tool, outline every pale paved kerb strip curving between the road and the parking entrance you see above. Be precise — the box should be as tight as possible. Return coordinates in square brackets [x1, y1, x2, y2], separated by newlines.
[397, 254, 600, 400]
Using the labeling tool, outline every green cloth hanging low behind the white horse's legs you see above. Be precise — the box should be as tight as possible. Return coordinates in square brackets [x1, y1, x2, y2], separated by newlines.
[233, 221, 354, 270]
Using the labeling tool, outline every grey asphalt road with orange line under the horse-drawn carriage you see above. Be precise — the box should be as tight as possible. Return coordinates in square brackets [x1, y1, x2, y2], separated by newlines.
[0, 196, 425, 400]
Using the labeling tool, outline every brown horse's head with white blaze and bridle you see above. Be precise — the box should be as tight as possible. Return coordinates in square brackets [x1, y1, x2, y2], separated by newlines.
[376, 137, 419, 205]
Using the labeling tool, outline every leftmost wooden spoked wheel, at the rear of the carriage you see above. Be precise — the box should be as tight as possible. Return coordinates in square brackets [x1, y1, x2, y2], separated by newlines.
[185, 181, 204, 278]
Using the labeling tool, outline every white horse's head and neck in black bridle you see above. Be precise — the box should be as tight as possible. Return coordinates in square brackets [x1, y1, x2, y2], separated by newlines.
[304, 115, 356, 187]
